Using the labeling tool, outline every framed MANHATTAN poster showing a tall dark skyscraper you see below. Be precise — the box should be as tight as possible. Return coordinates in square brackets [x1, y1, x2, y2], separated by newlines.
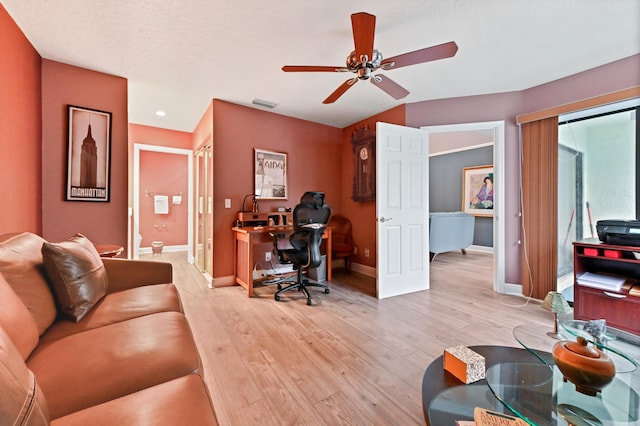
[66, 105, 111, 202]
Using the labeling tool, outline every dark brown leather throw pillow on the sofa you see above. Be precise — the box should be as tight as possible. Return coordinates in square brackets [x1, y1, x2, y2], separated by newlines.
[42, 234, 108, 322]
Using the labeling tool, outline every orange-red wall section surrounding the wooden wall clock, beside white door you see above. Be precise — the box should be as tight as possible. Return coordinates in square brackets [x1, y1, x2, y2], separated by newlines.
[334, 105, 406, 268]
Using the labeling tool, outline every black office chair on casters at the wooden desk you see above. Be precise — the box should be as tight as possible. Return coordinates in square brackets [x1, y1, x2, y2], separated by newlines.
[271, 192, 331, 305]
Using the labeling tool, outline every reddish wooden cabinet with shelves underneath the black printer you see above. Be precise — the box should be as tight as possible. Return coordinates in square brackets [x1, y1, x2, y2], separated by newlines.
[573, 239, 640, 334]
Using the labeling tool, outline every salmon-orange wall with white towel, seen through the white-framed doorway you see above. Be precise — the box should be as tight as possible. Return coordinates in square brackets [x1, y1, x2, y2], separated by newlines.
[139, 151, 190, 247]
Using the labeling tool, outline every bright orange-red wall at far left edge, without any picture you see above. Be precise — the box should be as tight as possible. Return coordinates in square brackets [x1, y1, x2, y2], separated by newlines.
[0, 4, 42, 234]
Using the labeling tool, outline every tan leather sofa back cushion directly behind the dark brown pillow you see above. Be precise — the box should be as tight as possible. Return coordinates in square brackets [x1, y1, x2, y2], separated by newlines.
[0, 232, 58, 334]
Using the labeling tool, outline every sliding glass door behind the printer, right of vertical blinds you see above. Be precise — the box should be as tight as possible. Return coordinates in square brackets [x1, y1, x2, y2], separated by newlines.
[558, 101, 640, 291]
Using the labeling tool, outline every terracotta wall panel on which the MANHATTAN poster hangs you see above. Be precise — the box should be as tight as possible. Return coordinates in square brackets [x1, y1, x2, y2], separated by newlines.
[42, 60, 129, 247]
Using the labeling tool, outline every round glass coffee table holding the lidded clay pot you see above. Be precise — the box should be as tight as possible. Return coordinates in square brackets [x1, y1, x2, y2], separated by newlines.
[422, 326, 640, 426]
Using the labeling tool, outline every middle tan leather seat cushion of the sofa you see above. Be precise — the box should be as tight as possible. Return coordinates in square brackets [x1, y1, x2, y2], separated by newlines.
[27, 312, 200, 418]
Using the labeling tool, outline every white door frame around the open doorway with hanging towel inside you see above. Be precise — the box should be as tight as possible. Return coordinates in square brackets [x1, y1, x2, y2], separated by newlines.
[129, 143, 193, 263]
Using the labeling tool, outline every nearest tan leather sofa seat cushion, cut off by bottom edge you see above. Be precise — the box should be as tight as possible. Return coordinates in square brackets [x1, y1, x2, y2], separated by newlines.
[51, 374, 218, 426]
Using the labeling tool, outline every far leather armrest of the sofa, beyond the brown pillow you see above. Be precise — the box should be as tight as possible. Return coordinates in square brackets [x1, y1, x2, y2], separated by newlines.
[102, 258, 173, 293]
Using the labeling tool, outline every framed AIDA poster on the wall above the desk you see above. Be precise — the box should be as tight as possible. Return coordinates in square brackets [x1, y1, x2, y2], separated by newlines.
[253, 148, 287, 200]
